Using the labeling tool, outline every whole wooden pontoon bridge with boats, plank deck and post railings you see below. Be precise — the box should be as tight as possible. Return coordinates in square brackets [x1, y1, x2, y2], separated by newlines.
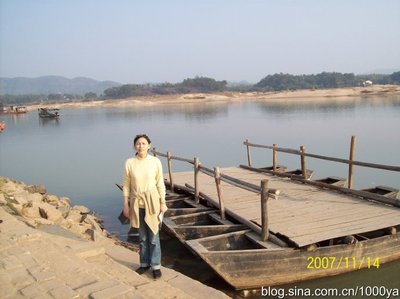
[147, 136, 400, 289]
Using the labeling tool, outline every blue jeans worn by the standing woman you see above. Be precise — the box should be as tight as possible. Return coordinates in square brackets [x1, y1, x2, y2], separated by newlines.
[139, 209, 161, 270]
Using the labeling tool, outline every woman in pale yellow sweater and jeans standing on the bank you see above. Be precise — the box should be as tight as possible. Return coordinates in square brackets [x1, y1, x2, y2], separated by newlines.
[123, 134, 168, 279]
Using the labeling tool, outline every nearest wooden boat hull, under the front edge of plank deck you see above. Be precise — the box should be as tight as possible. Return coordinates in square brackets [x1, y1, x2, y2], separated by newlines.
[186, 230, 400, 289]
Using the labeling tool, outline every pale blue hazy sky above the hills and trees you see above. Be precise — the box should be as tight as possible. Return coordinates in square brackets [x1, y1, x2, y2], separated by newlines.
[0, 0, 400, 84]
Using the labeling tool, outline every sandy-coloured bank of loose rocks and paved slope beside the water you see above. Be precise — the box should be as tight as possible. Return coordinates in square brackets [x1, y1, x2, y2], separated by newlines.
[0, 177, 228, 299]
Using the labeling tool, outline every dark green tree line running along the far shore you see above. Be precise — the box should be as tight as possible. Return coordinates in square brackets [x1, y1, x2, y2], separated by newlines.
[0, 71, 400, 104]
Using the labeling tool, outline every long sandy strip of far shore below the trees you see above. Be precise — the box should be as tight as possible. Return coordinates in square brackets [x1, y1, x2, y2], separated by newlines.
[27, 85, 400, 110]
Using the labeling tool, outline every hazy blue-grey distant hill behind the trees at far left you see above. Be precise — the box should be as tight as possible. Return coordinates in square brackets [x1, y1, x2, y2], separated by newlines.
[0, 76, 121, 95]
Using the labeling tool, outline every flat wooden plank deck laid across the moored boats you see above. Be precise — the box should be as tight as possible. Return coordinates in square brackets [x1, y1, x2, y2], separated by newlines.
[174, 167, 400, 246]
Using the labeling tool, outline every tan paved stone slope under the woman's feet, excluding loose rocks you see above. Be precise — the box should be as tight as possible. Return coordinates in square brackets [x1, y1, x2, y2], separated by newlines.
[0, 206, 229, 299]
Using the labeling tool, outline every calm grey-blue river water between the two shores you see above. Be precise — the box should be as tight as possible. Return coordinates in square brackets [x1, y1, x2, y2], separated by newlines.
[0, 96, 400, 298]
